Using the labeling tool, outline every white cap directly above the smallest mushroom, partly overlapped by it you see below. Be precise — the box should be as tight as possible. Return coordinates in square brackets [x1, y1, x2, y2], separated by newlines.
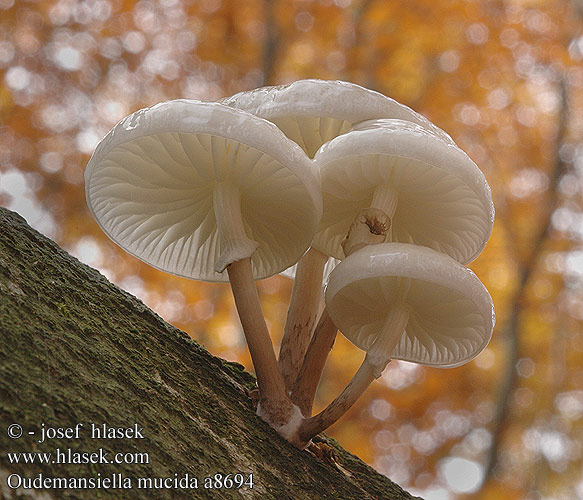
[312, 120, 494, 263]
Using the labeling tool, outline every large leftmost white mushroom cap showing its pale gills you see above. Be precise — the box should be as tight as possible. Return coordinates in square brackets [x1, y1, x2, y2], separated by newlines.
[85, 100, 322, 281]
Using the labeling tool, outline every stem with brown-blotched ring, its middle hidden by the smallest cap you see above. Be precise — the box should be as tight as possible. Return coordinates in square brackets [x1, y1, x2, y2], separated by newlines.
[291, 184, 399, 416]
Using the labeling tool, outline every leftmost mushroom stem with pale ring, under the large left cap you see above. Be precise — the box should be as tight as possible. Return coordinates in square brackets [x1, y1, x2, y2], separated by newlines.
[213, 182, 299, 438]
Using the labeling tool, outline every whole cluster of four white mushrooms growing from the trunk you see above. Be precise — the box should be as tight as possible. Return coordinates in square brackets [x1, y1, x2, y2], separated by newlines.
[85, 80, 494, 448]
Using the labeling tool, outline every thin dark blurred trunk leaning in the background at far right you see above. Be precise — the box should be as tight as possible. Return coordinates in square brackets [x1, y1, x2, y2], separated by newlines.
[482, 77, 569, 485]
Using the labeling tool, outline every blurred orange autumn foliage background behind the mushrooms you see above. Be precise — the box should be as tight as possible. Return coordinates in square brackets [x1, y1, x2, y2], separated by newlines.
[0, 0, 583, 500]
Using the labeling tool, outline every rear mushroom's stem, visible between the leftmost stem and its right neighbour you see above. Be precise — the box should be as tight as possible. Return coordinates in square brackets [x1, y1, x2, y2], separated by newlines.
[279, 248, 328, 390]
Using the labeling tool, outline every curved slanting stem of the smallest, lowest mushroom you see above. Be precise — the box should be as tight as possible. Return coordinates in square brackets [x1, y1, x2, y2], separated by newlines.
[298, 301, 409, 443]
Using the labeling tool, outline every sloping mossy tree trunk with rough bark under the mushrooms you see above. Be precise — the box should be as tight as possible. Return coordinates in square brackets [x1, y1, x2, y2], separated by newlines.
[0, 207, 422, 500]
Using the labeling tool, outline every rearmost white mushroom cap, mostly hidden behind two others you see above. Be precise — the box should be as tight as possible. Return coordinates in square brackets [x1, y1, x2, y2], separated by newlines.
[220, 80, 453, 158]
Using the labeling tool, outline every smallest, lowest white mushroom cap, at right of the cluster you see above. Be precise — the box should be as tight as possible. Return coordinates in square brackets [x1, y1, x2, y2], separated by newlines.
[325, 243, 495, 367]
